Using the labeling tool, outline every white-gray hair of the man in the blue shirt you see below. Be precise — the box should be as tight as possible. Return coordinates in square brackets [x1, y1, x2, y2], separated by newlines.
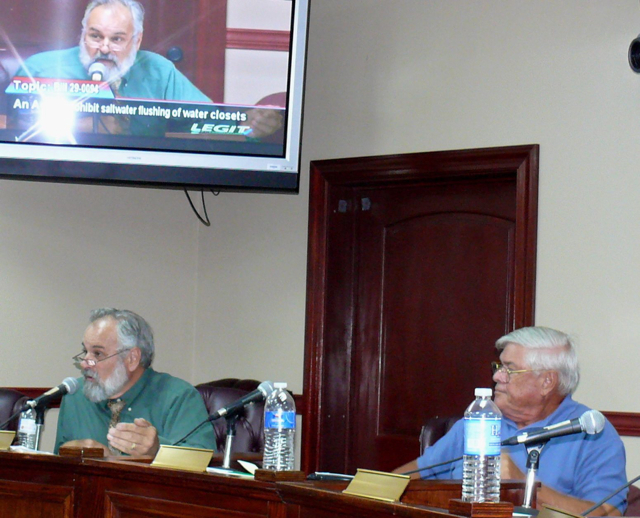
[496, 327, 580, 395]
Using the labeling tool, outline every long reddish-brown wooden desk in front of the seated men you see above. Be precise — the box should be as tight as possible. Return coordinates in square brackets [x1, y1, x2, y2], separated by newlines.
[0, 452, 523, 518]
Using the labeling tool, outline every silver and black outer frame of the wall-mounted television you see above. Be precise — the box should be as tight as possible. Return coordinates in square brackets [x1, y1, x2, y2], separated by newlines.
[0, 0, 309, 193]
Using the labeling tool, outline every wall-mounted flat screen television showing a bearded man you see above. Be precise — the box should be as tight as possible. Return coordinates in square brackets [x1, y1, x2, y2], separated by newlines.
[0, 0, 309, 193]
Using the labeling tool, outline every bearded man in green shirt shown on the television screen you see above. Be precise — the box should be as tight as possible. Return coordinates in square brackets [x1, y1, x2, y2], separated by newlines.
[15, 0, 282, 138]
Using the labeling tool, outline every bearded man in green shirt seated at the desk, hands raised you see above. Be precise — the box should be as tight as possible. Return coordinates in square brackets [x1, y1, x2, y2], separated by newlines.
[54, 308, 215, 457]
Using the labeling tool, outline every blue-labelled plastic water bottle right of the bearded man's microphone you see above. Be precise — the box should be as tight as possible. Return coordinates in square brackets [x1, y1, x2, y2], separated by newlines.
[262, 383, 296, 471]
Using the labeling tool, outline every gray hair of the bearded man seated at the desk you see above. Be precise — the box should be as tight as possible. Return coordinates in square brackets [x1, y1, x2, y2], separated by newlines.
[89, 308, 155, 369]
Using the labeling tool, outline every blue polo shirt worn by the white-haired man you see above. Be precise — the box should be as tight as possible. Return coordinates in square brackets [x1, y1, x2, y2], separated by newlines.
[418, 396, 627, 513]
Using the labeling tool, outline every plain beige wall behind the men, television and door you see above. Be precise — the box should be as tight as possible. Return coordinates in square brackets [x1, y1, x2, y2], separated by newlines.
[0, 0, 640, 476]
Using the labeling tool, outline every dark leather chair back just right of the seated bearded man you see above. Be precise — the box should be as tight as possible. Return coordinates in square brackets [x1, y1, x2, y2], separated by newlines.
[196, 378, 264, 453]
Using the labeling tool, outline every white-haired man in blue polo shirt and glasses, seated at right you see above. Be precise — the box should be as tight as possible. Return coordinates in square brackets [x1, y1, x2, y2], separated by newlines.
[395, 327, 627, 516]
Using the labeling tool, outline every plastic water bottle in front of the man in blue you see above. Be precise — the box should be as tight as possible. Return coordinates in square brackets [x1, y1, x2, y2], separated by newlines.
[462, 388, 502, 502]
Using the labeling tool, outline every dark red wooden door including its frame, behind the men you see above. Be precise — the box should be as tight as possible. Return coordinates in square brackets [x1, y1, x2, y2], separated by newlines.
[303, 146, 538, 473]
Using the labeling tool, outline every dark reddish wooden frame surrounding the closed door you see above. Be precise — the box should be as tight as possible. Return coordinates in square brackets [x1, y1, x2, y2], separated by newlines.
[301, 144, 539, 472]
